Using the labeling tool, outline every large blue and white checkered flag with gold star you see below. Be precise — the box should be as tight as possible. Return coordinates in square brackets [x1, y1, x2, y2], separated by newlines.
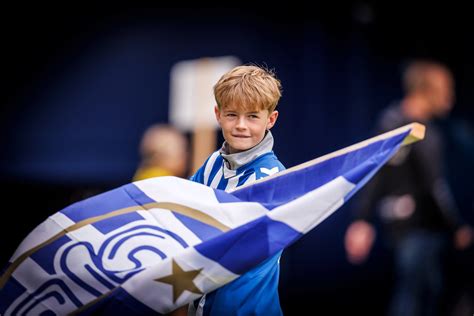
[0, 123, 424, 315]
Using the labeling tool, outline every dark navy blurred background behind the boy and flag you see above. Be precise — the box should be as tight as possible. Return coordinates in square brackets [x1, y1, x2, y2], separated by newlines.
[0, 1, 474, 315]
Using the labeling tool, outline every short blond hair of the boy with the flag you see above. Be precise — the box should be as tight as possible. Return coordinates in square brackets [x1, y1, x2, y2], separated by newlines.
[214, 65, 281, 113]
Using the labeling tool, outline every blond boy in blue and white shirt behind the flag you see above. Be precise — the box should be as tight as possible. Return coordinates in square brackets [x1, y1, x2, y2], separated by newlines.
[189, 66, 284, 315]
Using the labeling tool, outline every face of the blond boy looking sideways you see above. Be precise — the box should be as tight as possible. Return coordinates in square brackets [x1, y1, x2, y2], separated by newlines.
[214, 106, 278, 154]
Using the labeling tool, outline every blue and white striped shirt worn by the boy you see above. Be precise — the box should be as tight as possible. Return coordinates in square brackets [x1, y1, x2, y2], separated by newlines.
[191, 131, 285, 315]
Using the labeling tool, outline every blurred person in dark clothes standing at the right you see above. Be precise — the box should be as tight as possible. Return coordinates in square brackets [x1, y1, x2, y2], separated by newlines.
[345, 60, 472, 316]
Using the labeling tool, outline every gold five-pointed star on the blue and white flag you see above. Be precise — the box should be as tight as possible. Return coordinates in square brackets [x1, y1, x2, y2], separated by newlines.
[155, 259, 204, 303]
